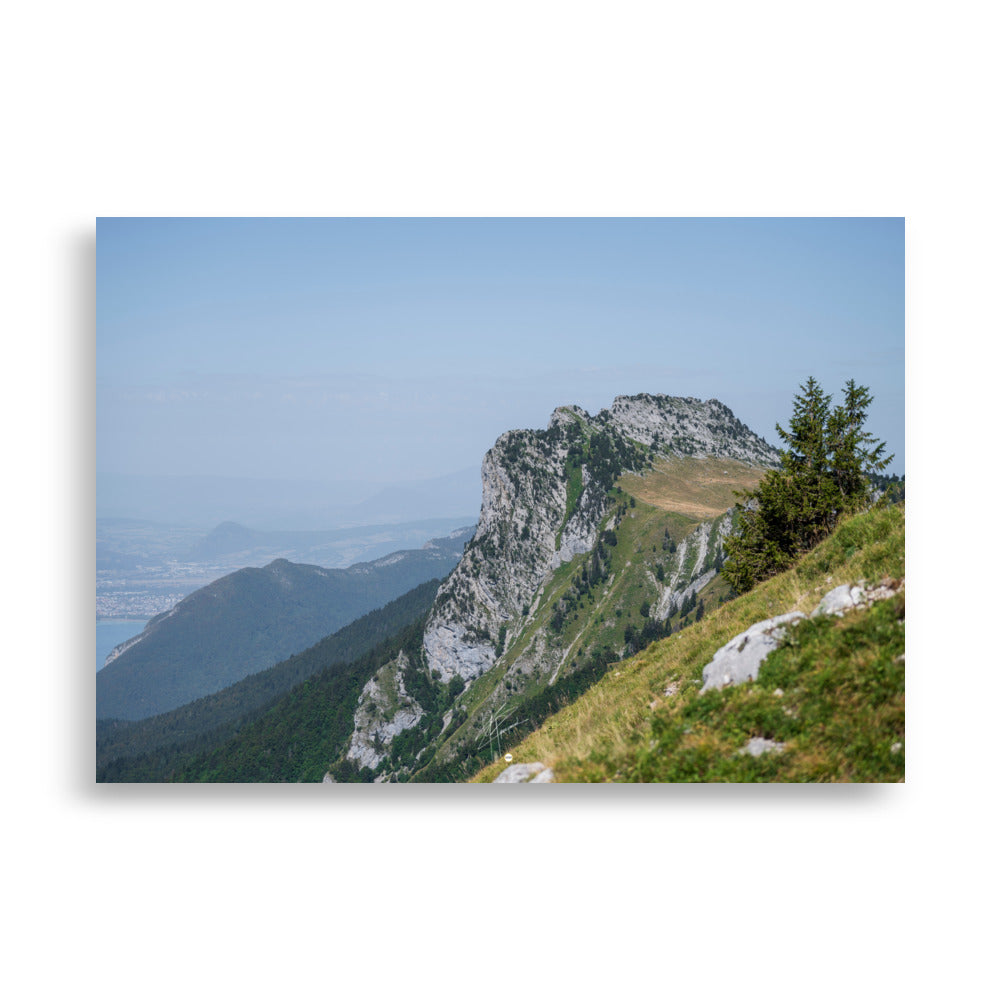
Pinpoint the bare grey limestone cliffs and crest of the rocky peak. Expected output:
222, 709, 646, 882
424, 395, 777, 680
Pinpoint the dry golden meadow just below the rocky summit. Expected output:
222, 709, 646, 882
618, 458, 764, 519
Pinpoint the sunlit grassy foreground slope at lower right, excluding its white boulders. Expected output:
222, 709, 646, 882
473, 506, 905, 781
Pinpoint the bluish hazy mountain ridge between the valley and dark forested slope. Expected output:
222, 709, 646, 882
97, 528, 473, 720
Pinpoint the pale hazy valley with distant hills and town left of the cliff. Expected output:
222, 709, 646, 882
96, 469, 481, 621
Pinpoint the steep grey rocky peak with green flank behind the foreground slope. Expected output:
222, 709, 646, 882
334, 395, 777, 780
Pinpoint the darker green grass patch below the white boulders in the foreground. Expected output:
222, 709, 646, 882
621, 595, 905, 782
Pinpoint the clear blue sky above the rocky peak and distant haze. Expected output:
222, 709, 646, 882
97, 219, 904, 504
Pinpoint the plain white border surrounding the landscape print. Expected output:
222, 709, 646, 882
0, 2, 997, 997
